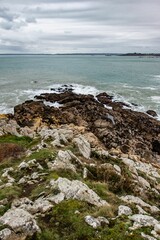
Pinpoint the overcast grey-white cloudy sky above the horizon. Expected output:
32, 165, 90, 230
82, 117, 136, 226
0, 0, 160, 53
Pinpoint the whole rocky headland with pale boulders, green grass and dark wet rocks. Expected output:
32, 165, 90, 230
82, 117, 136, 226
0, 86, 160, 240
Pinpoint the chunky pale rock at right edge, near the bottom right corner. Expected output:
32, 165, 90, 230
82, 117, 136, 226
129, 214, 158, 230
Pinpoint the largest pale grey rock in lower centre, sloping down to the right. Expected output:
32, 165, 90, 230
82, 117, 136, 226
50, 177, 109, 207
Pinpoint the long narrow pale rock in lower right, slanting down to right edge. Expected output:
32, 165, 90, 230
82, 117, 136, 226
120, 195, 160, 213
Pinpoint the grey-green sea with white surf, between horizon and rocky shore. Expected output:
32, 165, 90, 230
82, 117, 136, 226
0, 55, 160, 120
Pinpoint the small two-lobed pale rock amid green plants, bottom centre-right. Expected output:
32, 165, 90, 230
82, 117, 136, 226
85, 215, 109, 229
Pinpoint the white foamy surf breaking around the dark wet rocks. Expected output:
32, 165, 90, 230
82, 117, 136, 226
0, 83, 160, 120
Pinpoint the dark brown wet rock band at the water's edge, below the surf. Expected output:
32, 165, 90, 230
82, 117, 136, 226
11, 91, 160, 161
